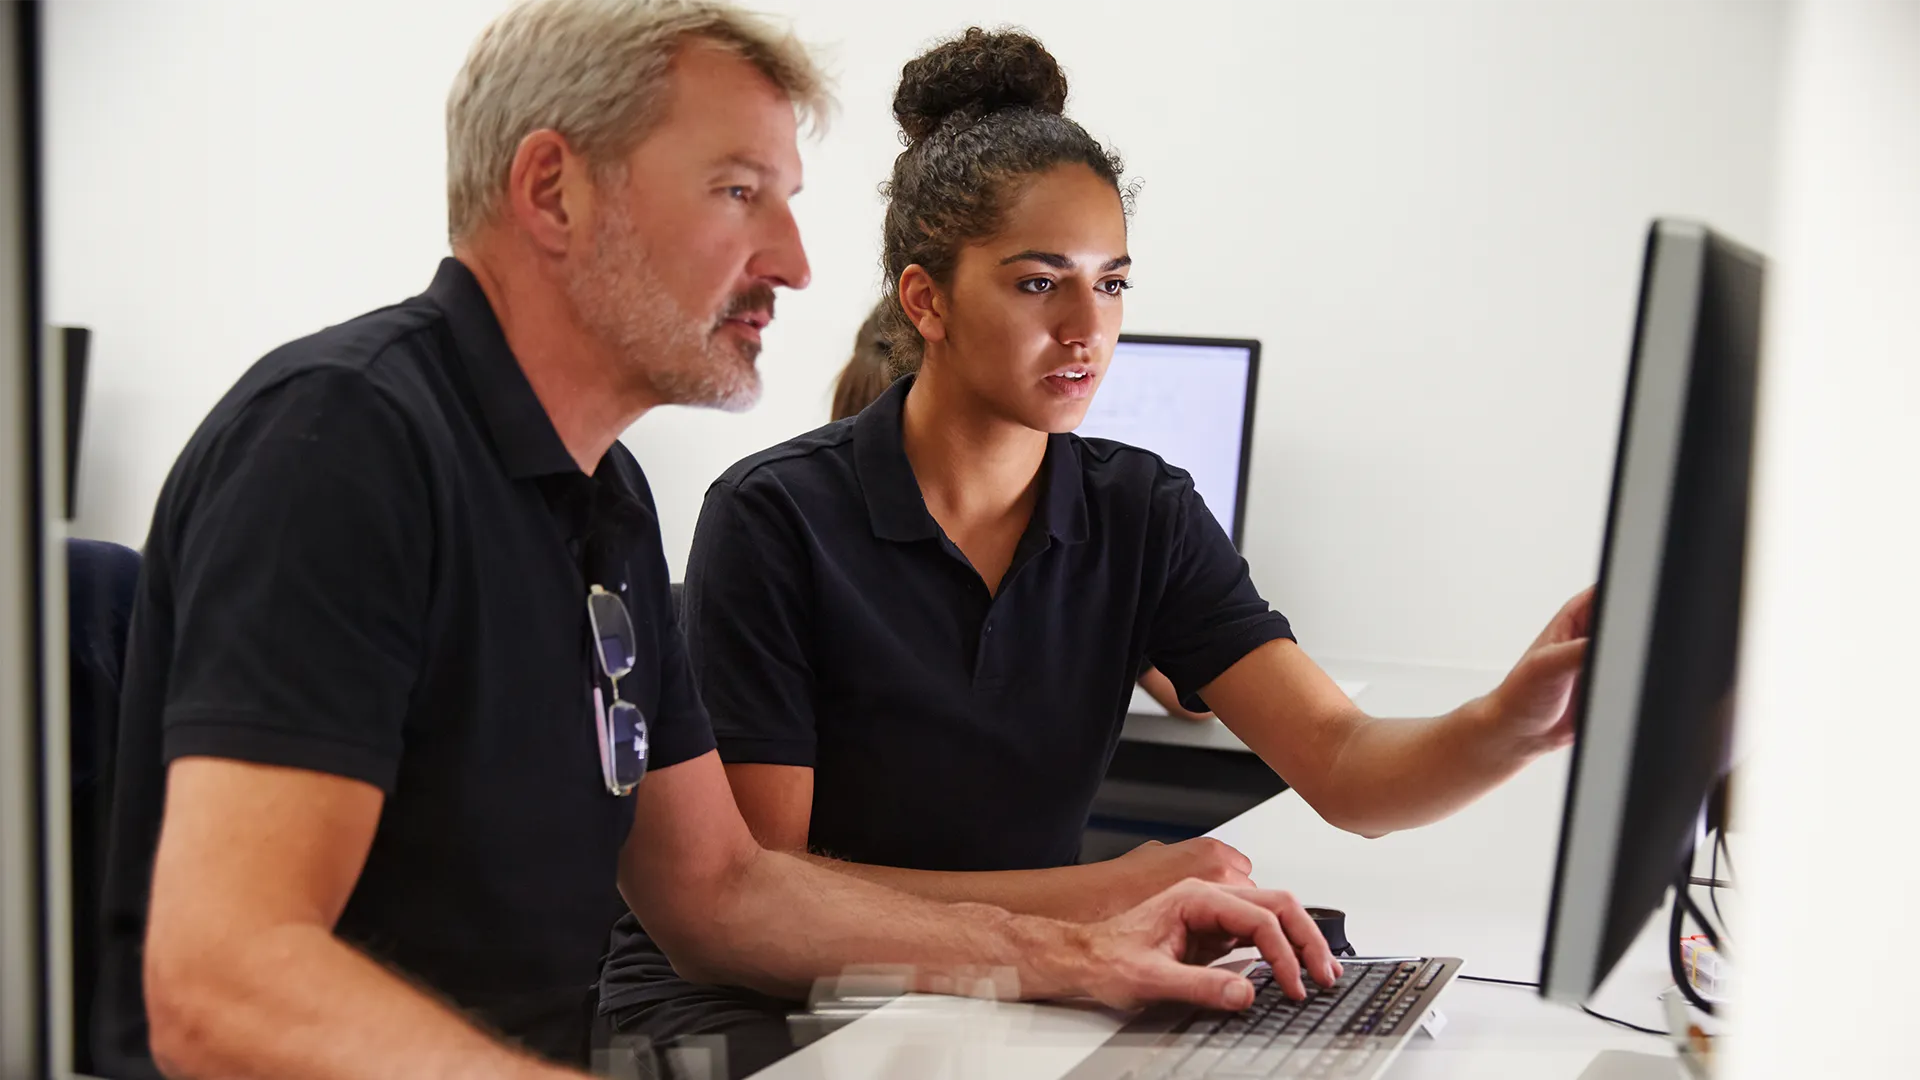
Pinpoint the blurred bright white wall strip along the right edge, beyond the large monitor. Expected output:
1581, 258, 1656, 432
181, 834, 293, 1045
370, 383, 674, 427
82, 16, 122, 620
1726, 0, 1920, 1060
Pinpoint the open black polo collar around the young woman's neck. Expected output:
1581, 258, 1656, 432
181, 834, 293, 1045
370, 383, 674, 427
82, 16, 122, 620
852, 375, 1087, 544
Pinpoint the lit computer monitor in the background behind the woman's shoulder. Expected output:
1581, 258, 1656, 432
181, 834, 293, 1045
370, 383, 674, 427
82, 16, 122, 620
1079, 334, 1260, 546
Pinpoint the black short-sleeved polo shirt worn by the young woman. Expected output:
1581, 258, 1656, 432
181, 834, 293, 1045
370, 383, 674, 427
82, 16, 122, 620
603, 368, 1292, 1007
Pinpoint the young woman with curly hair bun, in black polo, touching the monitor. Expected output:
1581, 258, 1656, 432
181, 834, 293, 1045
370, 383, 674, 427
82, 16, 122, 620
603, 29, 1586, 1068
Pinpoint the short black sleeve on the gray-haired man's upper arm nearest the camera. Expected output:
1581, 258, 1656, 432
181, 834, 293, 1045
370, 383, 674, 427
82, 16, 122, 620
163, 369, 432, 792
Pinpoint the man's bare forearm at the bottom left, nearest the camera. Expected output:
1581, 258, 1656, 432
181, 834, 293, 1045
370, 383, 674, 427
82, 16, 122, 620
146, 924, 580, 1080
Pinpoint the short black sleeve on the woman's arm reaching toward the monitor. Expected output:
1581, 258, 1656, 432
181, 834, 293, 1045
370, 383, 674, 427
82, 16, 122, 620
1146, 473, 1294, 709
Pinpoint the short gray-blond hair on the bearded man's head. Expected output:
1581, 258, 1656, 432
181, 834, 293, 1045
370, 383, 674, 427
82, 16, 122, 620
447, 0, 828, 244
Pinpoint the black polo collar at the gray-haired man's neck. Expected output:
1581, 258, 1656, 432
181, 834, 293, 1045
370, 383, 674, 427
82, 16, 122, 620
426, 258, 580, 480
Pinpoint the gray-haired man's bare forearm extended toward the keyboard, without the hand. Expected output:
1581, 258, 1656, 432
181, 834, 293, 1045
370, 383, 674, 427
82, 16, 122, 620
639, 849, 1087, 999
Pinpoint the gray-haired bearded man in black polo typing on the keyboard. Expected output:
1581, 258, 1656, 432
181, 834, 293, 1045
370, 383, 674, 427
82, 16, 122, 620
96, 0, 1334, 1080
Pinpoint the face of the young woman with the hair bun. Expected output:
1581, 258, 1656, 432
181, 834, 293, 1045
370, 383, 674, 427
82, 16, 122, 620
929, 165, 1133, 432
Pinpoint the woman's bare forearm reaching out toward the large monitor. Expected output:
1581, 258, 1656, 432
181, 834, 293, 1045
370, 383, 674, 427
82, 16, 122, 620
1302, 700, 1538, 836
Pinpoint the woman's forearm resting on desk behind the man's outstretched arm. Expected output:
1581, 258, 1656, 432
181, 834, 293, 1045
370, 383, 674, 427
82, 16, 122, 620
803, 853, 1158, 922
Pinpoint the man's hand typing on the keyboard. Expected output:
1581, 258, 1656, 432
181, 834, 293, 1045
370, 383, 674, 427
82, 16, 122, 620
1075, 880, 1340, 1009
